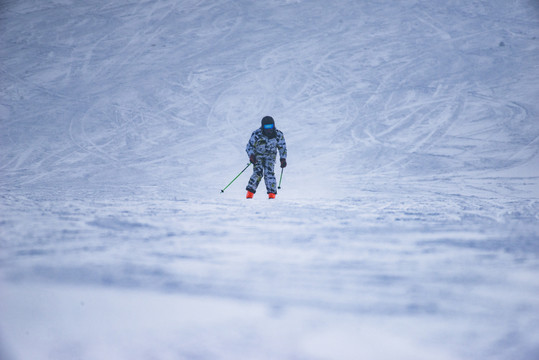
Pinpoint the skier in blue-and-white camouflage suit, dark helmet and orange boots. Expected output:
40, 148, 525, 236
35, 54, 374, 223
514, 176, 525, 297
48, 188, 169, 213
245, 116, 287, 199
